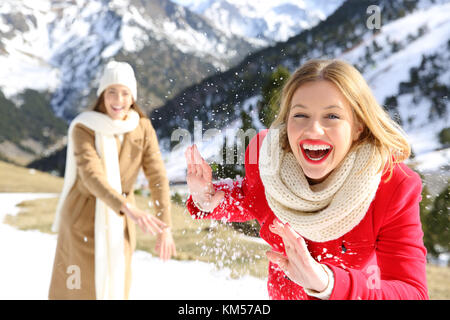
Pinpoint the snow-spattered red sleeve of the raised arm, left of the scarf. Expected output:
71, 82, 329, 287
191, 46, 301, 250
186, 130, 267, 222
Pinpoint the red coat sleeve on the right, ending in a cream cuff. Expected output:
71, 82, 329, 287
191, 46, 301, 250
326, 172, 429, 300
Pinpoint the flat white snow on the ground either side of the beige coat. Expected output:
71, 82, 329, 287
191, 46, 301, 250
0, 193, 268, 300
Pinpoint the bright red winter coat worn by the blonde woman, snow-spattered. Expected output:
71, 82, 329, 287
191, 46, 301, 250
186, 130, 428, 300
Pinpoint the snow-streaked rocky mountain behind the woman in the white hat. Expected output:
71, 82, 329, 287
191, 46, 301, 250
0, 0, 255, 119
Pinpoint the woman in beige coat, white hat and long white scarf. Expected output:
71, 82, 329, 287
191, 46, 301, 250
49, 61, 176, 299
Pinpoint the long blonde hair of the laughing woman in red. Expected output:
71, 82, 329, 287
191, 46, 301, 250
271, 59, 411, 181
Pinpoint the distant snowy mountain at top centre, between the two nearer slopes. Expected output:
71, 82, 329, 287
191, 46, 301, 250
174, 0, 344, 45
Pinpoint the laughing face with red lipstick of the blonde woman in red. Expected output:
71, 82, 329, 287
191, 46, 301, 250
287, 80, 363, 184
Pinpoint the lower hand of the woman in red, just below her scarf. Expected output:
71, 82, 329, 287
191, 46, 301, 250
266, 219, 328, 292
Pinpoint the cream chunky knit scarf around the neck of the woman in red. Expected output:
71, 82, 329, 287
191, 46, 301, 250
259, 127, 381, 242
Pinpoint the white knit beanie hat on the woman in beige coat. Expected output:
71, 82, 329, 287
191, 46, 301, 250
97, 61, 137, 101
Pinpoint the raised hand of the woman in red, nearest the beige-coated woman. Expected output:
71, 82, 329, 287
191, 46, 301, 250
184, 144, 225, 211
